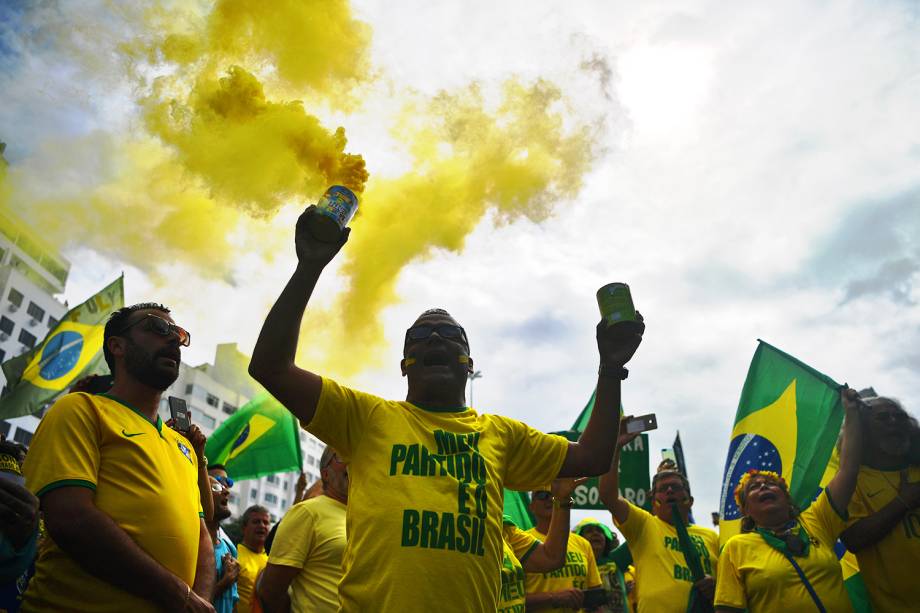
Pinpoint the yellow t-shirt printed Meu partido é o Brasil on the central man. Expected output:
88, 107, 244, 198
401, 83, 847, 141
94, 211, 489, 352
305, 379, 568, 613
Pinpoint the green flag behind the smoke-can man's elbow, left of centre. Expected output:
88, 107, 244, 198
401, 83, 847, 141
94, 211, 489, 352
205, 393, 303, 481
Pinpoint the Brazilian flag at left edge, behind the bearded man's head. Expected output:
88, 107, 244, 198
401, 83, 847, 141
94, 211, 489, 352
0, 277, 125, 419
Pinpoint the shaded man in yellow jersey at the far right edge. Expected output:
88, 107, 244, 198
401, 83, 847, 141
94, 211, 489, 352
841, 394, 920, 613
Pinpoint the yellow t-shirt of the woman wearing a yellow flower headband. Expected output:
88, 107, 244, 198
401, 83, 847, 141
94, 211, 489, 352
712, 490, 853, 613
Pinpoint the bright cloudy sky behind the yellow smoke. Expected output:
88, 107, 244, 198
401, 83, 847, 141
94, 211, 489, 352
0, 1, 920, 516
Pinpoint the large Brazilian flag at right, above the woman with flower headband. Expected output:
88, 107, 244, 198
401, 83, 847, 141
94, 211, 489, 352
719, 341, 843, 545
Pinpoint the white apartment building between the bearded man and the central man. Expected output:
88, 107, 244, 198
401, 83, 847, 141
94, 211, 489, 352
160, 343, 325, 522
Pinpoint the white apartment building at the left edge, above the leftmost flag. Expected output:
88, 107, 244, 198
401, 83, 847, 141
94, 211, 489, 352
0, 207, 70, 445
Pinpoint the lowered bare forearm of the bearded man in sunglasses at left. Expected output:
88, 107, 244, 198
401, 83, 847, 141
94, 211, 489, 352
41, 487, 214, 611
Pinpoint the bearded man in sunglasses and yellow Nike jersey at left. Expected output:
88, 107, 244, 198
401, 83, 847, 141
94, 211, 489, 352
22, 303, 214, 613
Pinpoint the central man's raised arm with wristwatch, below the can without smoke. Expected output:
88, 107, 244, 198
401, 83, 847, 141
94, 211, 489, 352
559, 313, 645, 477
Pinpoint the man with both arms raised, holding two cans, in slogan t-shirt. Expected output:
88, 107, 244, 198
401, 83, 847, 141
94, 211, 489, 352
249, 208, 645, 613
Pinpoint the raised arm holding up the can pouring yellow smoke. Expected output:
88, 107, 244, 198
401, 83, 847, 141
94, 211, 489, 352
249, 206, 349, 423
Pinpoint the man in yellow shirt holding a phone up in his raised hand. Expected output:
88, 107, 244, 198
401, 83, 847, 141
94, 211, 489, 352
599, 424, 719, 613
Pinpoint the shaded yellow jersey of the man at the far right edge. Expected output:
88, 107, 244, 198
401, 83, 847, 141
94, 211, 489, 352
847, 466, 920, 613
